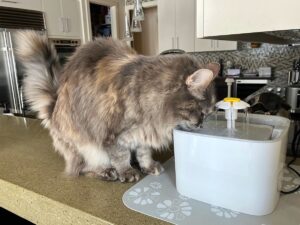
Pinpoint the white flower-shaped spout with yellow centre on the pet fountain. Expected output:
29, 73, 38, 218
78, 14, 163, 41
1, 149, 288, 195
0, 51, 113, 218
216, 97, 250, 129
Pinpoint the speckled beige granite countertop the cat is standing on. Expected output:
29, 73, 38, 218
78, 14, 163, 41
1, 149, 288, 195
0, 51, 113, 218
0, 116, 171, 225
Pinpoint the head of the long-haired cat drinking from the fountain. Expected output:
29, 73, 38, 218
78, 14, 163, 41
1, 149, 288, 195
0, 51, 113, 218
171, 63, 220, 126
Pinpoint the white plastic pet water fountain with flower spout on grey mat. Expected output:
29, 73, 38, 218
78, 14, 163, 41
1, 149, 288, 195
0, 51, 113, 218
174, 89, 290, 215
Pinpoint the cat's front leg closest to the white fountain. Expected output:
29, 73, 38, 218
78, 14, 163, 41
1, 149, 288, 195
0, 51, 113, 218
136, 147, 164, 175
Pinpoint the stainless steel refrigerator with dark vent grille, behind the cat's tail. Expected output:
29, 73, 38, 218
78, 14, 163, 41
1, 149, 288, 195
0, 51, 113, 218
0, 7, 46, 116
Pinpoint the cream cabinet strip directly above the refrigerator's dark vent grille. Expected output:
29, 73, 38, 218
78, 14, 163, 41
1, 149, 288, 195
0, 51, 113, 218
0, 0, 42, 11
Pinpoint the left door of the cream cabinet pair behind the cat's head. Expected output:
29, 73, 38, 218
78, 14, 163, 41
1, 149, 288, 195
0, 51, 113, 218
157, 0, 176, 53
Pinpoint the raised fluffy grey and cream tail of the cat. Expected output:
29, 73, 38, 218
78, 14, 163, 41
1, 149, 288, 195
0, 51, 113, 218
16, 31, 60, 127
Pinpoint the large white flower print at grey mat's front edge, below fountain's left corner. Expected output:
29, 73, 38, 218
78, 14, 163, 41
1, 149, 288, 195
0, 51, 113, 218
156, 199, 192, 221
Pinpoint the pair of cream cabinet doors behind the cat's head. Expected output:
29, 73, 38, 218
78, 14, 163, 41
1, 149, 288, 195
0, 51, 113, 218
157, 0, 195, 52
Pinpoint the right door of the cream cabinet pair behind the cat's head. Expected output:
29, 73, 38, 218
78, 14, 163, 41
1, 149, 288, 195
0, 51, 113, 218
175, 0, 195, 52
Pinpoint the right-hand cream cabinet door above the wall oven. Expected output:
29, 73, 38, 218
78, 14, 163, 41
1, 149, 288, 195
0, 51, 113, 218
61, 0, 81, 38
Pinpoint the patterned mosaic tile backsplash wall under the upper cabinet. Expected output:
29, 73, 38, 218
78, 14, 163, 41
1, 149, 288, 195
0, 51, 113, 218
192, 43, 300, 93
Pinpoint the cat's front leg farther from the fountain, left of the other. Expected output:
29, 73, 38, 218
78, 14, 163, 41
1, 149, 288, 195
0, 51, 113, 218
108, 145, 140, 182
